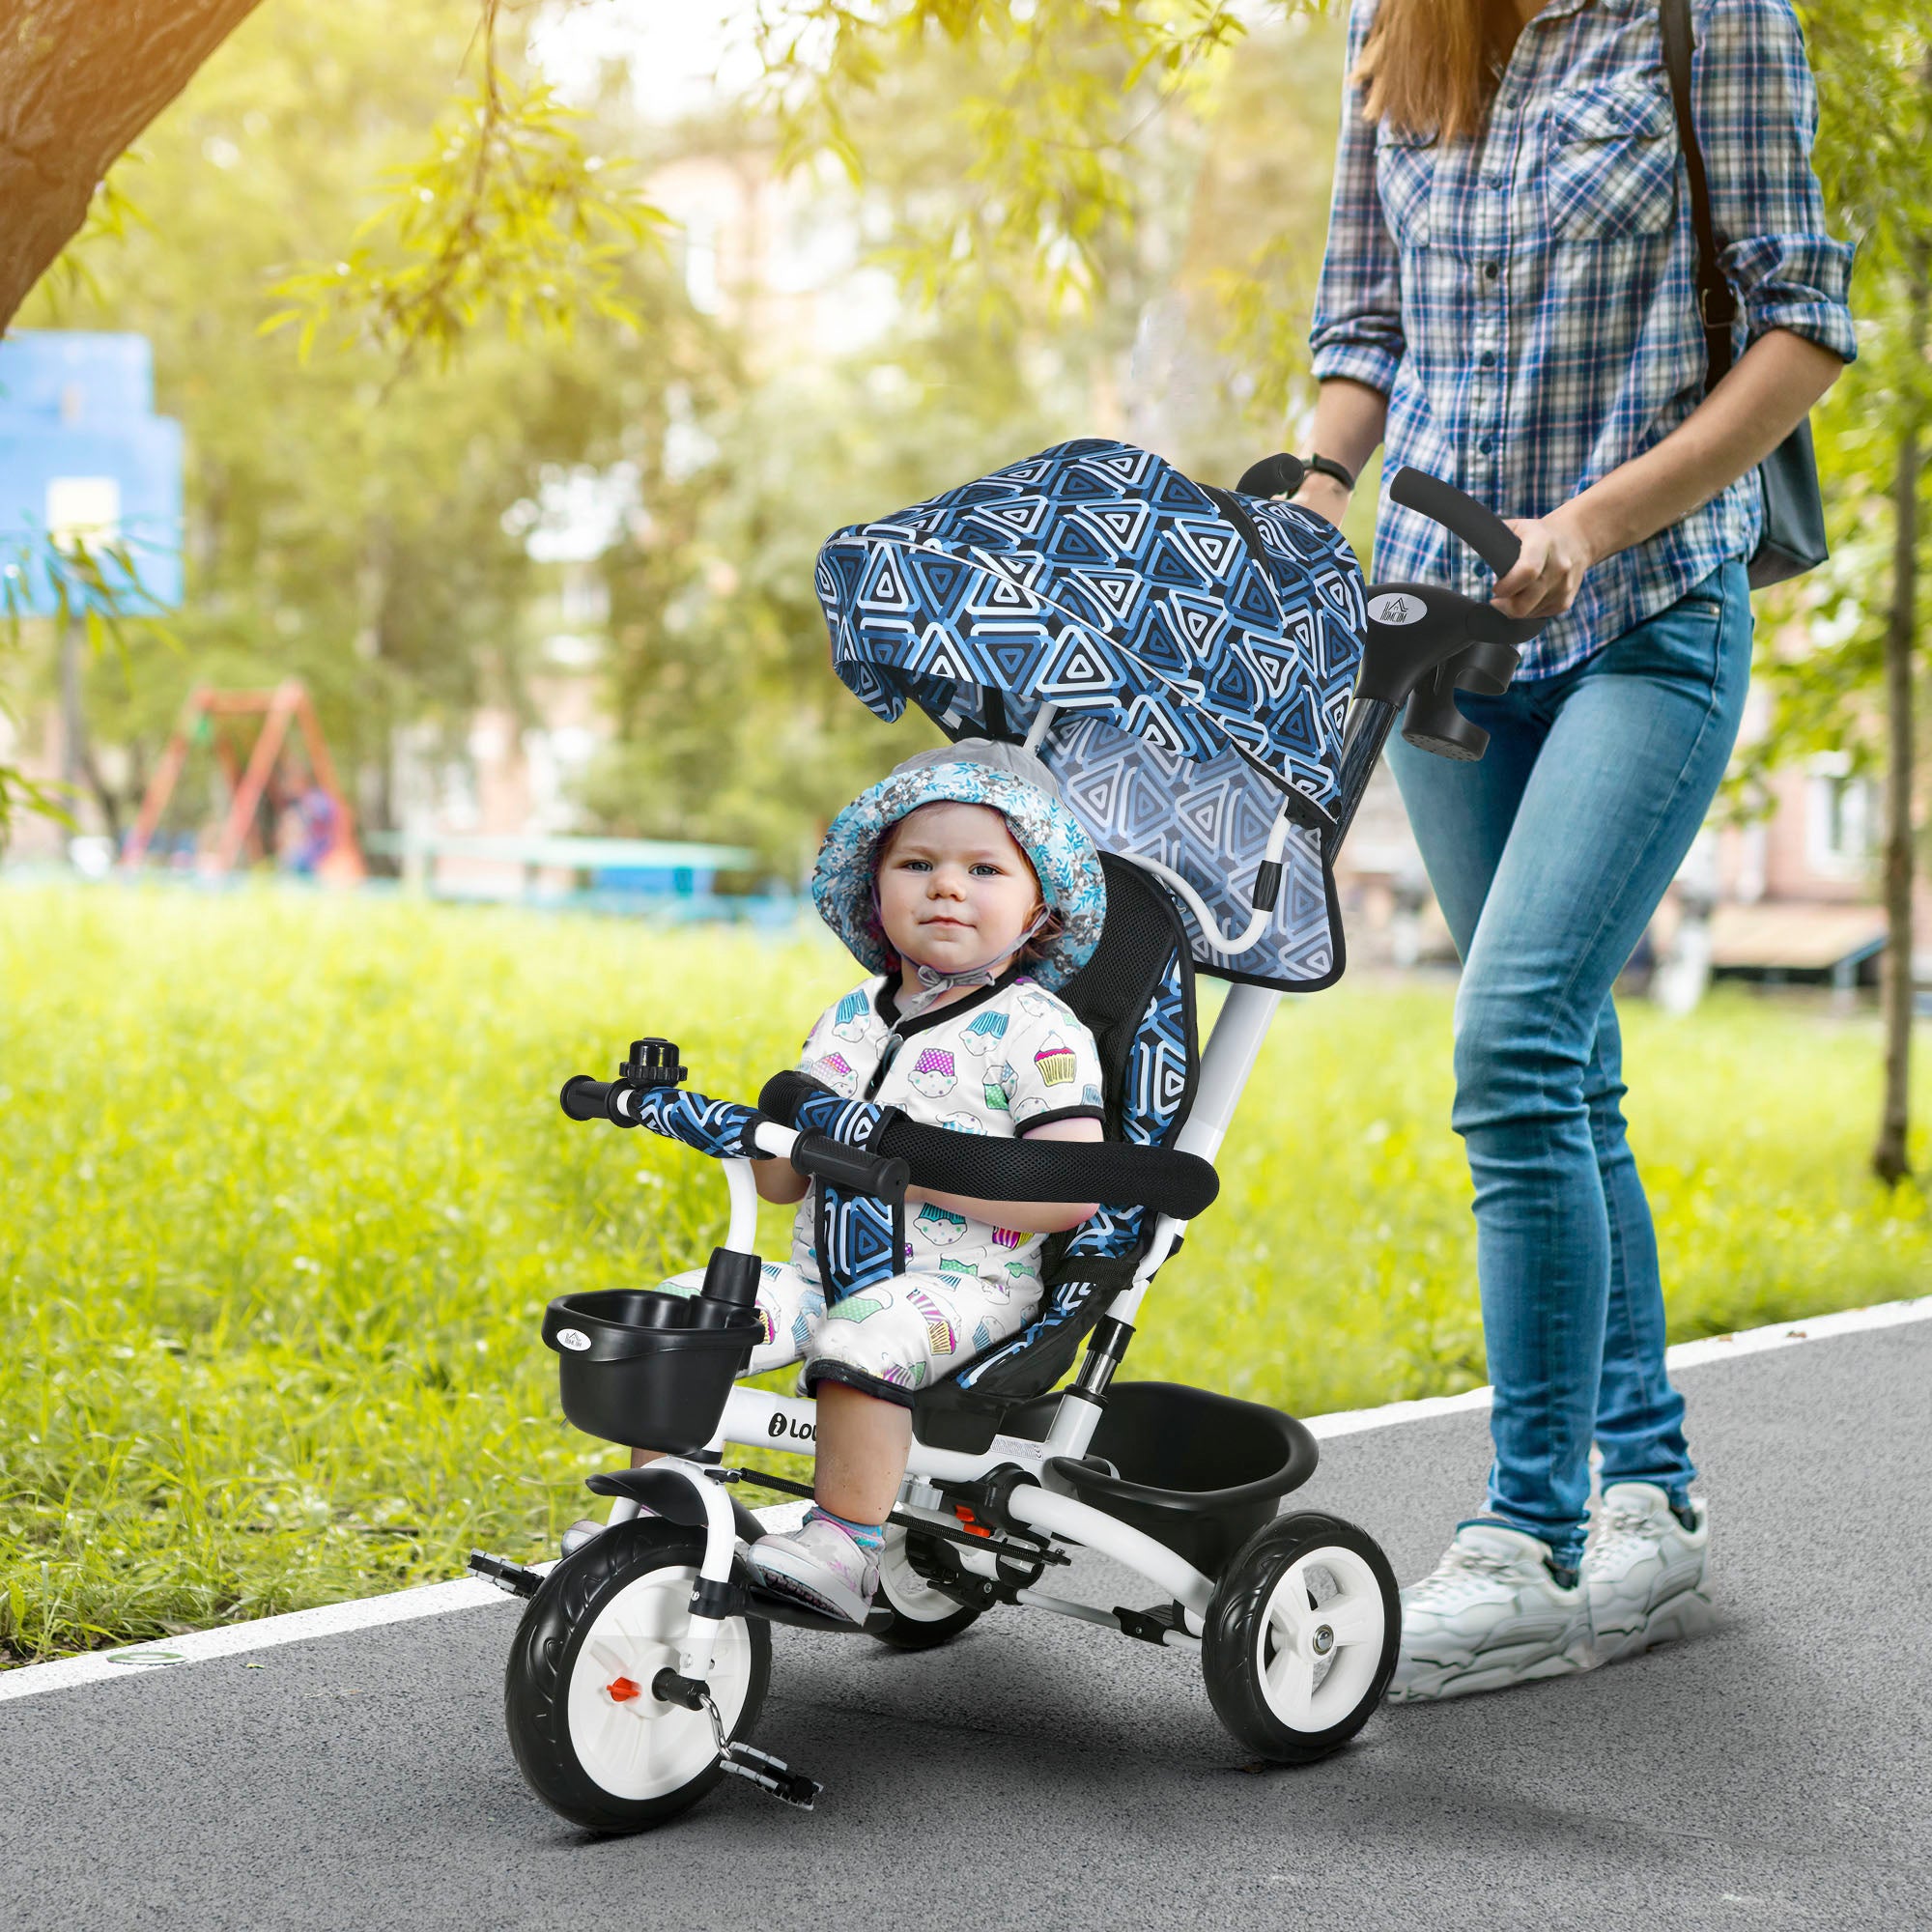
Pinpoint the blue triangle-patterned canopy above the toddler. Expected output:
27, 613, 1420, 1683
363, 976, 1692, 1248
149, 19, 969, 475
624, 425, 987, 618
817, 437, 1366, 991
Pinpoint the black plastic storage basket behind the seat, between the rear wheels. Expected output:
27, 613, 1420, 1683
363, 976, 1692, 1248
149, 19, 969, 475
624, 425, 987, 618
1043, 1381, 1320, 1577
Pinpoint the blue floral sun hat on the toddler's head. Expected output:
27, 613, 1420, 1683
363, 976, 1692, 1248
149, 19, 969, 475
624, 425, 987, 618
811, 738, 1107, 989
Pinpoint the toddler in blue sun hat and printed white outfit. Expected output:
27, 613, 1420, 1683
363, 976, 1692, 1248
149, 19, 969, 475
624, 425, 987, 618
667, 740, 1107, 1623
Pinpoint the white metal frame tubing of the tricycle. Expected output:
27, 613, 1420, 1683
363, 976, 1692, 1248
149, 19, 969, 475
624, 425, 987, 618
595, 985, 1281, 1679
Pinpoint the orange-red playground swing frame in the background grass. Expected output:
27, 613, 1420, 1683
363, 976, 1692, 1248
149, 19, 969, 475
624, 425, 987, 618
120, 678, 367, 885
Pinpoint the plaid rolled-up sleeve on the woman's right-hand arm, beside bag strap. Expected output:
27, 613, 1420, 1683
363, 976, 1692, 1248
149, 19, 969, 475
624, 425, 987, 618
1690, 0, 1859, 361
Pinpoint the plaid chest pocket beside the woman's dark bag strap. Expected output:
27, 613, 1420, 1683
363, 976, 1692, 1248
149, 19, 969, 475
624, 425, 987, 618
1544, 87, 1677, 242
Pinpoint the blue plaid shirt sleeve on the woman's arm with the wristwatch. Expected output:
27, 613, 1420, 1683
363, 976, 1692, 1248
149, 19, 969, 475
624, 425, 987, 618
1308, 0, 1405, 396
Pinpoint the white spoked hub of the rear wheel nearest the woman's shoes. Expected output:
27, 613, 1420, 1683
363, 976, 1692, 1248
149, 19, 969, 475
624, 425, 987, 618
1254, 1544, 1387, 1733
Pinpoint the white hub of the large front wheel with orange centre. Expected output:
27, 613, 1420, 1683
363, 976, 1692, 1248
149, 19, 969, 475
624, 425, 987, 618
564, 1565, 752, 1799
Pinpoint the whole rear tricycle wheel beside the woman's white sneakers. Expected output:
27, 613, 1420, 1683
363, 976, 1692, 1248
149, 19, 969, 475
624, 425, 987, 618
1202, 1513, 1403, 1764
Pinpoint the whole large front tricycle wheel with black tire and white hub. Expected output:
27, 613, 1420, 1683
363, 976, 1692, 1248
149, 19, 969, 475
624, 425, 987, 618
504, 1517, 771, 1832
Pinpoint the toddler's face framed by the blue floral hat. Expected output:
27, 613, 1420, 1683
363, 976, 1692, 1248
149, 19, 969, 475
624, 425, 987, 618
879, 804, 1039, 972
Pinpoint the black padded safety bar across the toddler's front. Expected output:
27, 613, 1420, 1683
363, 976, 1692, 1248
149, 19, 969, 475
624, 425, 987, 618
757, 1068, 1221, 1221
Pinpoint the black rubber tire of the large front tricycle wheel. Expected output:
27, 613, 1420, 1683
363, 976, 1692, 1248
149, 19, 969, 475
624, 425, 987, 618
502, 1517, 771, 1832
